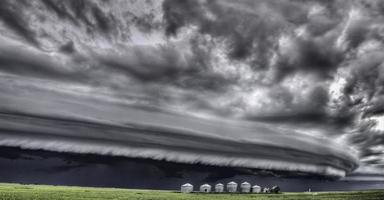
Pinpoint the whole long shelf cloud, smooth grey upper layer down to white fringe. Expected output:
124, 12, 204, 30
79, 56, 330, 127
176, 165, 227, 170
0, 74, 357, 177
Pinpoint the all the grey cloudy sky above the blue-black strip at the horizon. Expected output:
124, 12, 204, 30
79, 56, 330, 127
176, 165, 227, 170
0, 0, 384, 191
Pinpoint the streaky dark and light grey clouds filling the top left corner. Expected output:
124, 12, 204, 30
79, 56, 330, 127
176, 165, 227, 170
0, 0, 161, 49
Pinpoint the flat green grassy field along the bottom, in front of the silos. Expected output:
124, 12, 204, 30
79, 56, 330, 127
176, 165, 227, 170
0, 184, 384, 200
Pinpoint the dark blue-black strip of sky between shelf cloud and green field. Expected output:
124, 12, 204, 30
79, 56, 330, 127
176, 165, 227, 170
0, 147, 384, 192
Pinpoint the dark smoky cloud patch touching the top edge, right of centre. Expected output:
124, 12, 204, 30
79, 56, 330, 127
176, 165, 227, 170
163, 0, 282, 63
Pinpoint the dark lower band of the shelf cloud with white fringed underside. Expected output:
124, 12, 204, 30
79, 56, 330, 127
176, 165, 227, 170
0, 113, 356, 177
